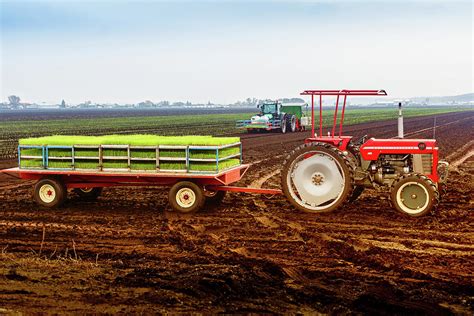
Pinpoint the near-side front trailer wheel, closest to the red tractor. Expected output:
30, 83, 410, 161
168, 181, 205, 213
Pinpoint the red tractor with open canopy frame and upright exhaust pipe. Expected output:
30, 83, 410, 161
281, 90, 448, 216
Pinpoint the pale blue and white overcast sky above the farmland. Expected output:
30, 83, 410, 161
0, 0, 474, 103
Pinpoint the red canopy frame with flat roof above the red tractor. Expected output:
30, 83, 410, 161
301, 90, 387, 138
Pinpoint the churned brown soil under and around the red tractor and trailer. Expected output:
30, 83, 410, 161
0, 111, 474, 314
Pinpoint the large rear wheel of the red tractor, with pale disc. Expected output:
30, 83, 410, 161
281, 143, 354, 213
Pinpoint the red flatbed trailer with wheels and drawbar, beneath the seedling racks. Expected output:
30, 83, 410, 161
0, 164, 281, 213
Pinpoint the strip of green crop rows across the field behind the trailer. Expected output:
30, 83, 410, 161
4, 107, 467, 140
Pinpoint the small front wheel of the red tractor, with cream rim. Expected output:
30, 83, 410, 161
390, 174, 439, 217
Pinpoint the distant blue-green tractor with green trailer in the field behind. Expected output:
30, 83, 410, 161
236, 101, 311, 133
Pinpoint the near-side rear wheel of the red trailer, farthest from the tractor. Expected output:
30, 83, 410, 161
33, 179, 67, 208
